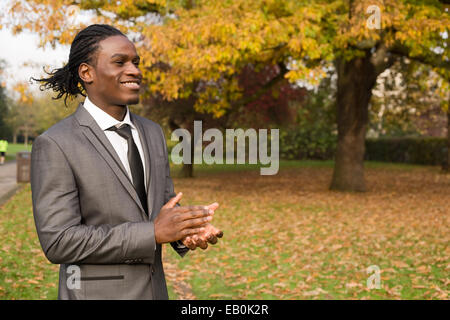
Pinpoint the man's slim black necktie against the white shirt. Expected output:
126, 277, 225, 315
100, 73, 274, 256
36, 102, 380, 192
110, 124, 148, 214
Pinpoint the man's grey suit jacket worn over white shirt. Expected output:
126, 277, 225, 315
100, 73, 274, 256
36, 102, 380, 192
31, 104, 189, 299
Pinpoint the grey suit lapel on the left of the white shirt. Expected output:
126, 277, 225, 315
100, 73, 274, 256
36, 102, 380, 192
75, 103, 148, 220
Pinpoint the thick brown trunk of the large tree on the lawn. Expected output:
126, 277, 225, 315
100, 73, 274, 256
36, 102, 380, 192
330, 52, 377, 192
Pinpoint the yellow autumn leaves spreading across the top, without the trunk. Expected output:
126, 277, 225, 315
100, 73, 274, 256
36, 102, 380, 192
0, 0, 450, 117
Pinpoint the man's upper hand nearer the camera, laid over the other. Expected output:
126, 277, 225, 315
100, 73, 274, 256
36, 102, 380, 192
154, 192, 213, 244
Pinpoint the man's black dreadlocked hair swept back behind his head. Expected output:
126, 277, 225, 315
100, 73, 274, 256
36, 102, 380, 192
31, 24, 125, 107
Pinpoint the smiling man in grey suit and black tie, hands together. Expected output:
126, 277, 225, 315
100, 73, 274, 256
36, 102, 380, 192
31, 25, 222, 299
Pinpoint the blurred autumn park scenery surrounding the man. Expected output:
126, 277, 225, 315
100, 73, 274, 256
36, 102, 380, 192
0, 0, 450, 299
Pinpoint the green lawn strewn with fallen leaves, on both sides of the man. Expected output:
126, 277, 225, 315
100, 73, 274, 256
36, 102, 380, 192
0, 161, 450, 299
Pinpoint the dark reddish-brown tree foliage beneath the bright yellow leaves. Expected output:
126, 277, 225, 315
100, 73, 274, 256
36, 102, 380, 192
142, 65, 306, 177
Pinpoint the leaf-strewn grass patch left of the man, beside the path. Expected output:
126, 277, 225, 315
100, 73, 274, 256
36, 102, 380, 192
0, 184, 58, 300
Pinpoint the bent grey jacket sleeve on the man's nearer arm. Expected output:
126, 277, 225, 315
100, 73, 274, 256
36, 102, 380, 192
31, 135, 155, 264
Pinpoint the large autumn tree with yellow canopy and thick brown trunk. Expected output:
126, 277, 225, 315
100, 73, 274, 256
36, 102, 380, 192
6, 0, 450, 191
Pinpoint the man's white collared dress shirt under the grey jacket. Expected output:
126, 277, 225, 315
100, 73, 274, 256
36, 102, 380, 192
83, 97, 147, 191
